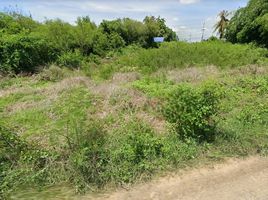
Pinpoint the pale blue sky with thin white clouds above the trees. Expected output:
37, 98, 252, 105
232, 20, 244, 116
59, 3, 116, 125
0, 0, 247, 41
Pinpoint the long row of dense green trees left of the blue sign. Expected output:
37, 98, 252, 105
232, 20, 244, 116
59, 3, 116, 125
0, 13, 176, 73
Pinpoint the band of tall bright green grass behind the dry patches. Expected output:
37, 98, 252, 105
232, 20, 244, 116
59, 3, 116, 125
111, 41, 268, 73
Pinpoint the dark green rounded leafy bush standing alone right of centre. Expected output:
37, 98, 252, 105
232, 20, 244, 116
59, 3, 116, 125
163, 84, 220, 141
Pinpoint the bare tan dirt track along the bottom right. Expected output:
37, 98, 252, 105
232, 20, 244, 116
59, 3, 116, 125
94, 157, 268, 200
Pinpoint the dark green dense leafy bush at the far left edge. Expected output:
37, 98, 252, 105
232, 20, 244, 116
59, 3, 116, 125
0, 34, 57, 73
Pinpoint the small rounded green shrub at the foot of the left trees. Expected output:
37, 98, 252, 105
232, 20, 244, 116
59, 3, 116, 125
57, 50, 83, 68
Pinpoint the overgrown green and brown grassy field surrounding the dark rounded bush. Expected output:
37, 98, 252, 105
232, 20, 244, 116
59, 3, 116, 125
0, 42, 268, 198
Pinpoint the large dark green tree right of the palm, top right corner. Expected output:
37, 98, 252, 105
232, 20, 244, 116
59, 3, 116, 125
226, 0, 268, 47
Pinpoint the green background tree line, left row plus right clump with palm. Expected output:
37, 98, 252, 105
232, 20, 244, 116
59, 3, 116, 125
0, 0, 268, 74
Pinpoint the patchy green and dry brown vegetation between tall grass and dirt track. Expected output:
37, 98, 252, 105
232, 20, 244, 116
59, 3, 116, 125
0, 63, 268, 198
